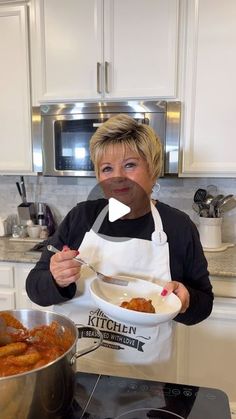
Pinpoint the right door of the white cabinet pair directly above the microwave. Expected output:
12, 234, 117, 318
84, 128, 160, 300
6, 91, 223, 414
104, 0, 178, 98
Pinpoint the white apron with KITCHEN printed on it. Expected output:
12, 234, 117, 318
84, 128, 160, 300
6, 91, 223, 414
54, 203, 176, 381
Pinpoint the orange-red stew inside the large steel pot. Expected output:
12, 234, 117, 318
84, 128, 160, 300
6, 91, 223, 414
0, 312, 74, 377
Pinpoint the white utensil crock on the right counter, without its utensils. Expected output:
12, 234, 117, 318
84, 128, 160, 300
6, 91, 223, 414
199, 217, 222, 249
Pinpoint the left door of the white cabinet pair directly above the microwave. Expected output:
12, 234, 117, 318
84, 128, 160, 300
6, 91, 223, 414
31, 0, 102, 101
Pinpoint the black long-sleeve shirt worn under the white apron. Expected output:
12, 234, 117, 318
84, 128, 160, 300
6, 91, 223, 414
26, 199, 213, 325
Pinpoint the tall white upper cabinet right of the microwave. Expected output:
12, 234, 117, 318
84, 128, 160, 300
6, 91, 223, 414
179, 0, 236, 177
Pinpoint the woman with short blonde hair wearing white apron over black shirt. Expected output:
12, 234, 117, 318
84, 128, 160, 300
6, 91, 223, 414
26, 115, 213, 381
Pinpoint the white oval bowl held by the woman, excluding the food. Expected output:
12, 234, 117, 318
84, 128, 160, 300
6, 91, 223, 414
90, 276, 181, 327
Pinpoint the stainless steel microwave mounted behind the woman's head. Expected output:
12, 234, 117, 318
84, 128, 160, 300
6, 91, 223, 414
33, 101, 181, 177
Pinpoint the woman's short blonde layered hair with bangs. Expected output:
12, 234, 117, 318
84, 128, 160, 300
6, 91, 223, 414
90, 114, 162, 180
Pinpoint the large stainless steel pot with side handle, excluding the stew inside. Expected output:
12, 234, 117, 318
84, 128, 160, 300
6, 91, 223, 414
0, 310, 102, 419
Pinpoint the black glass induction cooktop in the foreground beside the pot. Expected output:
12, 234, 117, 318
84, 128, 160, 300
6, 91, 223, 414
67, 372, 231, 419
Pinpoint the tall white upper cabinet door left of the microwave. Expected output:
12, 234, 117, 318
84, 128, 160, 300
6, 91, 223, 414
0, 4, 32, 174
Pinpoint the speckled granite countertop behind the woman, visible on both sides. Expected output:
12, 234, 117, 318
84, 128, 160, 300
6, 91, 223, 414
0, 237, 236, 278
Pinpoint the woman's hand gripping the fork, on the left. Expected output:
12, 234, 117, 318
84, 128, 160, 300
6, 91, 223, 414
50, 246, 81, 288
